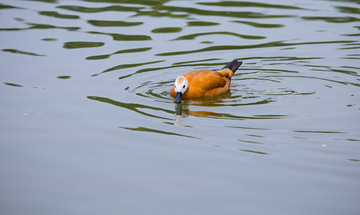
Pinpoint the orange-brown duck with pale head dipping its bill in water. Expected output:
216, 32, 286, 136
170, 59, 243, 103
